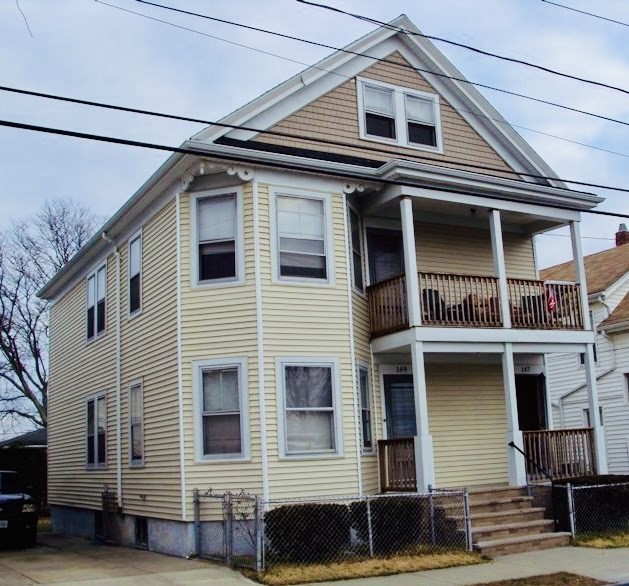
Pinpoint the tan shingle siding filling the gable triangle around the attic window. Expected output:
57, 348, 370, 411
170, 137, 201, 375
255, 53, 517, 178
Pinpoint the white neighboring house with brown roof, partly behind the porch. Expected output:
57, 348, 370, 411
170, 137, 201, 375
540, 224, 629, 474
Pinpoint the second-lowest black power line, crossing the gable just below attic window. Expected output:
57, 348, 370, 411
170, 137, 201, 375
0, 86, 626, 189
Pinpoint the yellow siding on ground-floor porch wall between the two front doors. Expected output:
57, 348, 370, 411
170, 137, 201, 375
426, 364, 509, 487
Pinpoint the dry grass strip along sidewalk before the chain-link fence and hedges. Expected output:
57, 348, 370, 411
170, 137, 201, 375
247, 551, 480, 586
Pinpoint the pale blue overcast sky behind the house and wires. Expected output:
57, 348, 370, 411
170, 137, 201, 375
0, 0, 629, 266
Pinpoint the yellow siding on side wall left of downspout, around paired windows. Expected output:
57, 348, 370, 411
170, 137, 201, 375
48, 255, 116, 509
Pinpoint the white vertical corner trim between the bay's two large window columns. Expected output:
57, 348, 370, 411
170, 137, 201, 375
251, 179, 270, 501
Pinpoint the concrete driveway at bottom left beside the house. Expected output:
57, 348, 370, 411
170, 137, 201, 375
0, 534, 252, 586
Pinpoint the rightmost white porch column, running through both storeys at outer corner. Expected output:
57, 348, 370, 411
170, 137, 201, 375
570, 220, 607, 474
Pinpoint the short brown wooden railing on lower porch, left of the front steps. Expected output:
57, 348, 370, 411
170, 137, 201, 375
378, 437, 417, 492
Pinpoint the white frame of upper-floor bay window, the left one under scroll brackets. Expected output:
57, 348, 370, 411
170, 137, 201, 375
190, 186, 245, 288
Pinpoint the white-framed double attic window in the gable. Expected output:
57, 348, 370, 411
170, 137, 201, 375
358, 79, 442, 152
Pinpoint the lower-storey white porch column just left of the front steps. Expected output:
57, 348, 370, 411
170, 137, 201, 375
411, 342, 435, 492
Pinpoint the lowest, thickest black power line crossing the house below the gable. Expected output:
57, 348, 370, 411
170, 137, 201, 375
0, 120, 629, 218
